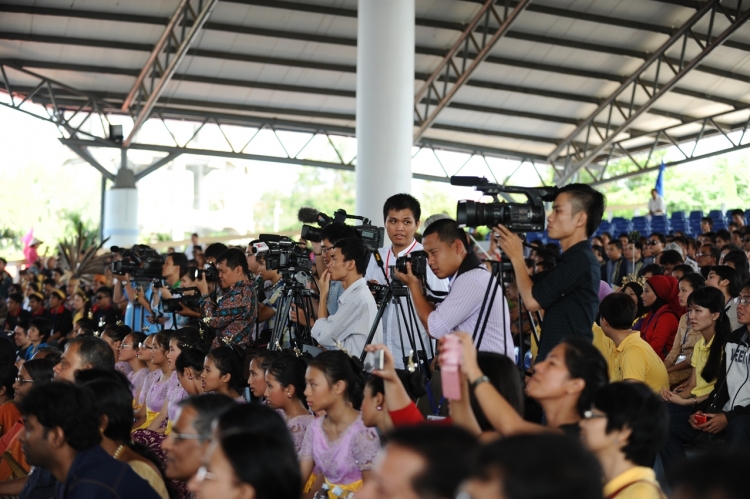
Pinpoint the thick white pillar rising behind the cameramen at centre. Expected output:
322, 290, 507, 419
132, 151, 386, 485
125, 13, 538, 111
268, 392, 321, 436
356, 0, 415, 225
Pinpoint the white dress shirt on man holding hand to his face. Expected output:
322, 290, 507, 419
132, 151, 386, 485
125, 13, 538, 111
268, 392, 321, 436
311, 278, 383, 358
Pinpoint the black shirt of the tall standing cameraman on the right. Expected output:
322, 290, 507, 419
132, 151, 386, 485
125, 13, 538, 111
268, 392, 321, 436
531, 241, 601, 360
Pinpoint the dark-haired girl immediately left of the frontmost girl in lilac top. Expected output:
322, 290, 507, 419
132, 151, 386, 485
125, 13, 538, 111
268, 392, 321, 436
265, 352, 315, 454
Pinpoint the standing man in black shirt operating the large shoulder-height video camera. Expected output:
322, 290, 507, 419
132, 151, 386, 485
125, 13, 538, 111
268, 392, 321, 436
494, 184, 606, 360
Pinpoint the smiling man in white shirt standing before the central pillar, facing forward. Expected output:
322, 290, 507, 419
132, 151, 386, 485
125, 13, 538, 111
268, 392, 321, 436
365, 194, 449, 369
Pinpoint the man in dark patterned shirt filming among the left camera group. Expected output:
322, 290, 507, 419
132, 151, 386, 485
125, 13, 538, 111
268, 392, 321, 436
195, 248, 258, 348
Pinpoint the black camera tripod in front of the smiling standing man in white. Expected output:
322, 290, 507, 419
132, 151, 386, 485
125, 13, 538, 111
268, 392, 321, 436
360, 252, 435, 378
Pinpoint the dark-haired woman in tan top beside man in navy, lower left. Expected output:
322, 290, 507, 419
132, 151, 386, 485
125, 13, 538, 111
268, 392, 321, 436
76, 369, 170, 499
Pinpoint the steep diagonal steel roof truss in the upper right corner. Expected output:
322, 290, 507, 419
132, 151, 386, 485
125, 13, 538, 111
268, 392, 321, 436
548, 0, 750, 185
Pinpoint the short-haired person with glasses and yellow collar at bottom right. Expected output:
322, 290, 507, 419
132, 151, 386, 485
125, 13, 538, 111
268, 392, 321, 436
581, 381, 669, 499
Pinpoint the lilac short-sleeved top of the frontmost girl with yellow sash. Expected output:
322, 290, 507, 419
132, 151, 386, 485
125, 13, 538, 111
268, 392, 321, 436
299, 416, 380, 485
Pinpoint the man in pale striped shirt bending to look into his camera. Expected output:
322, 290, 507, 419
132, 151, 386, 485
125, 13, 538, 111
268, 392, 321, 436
396, 219, 526, 359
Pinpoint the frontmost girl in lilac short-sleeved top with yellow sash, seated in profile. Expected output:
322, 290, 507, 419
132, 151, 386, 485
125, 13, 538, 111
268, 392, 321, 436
299, 350, 380, 499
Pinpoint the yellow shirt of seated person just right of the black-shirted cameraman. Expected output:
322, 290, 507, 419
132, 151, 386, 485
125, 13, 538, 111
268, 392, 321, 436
607, 332, 669, 393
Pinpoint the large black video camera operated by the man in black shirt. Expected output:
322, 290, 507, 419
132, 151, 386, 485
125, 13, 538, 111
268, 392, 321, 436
451, 176, 557, 232
